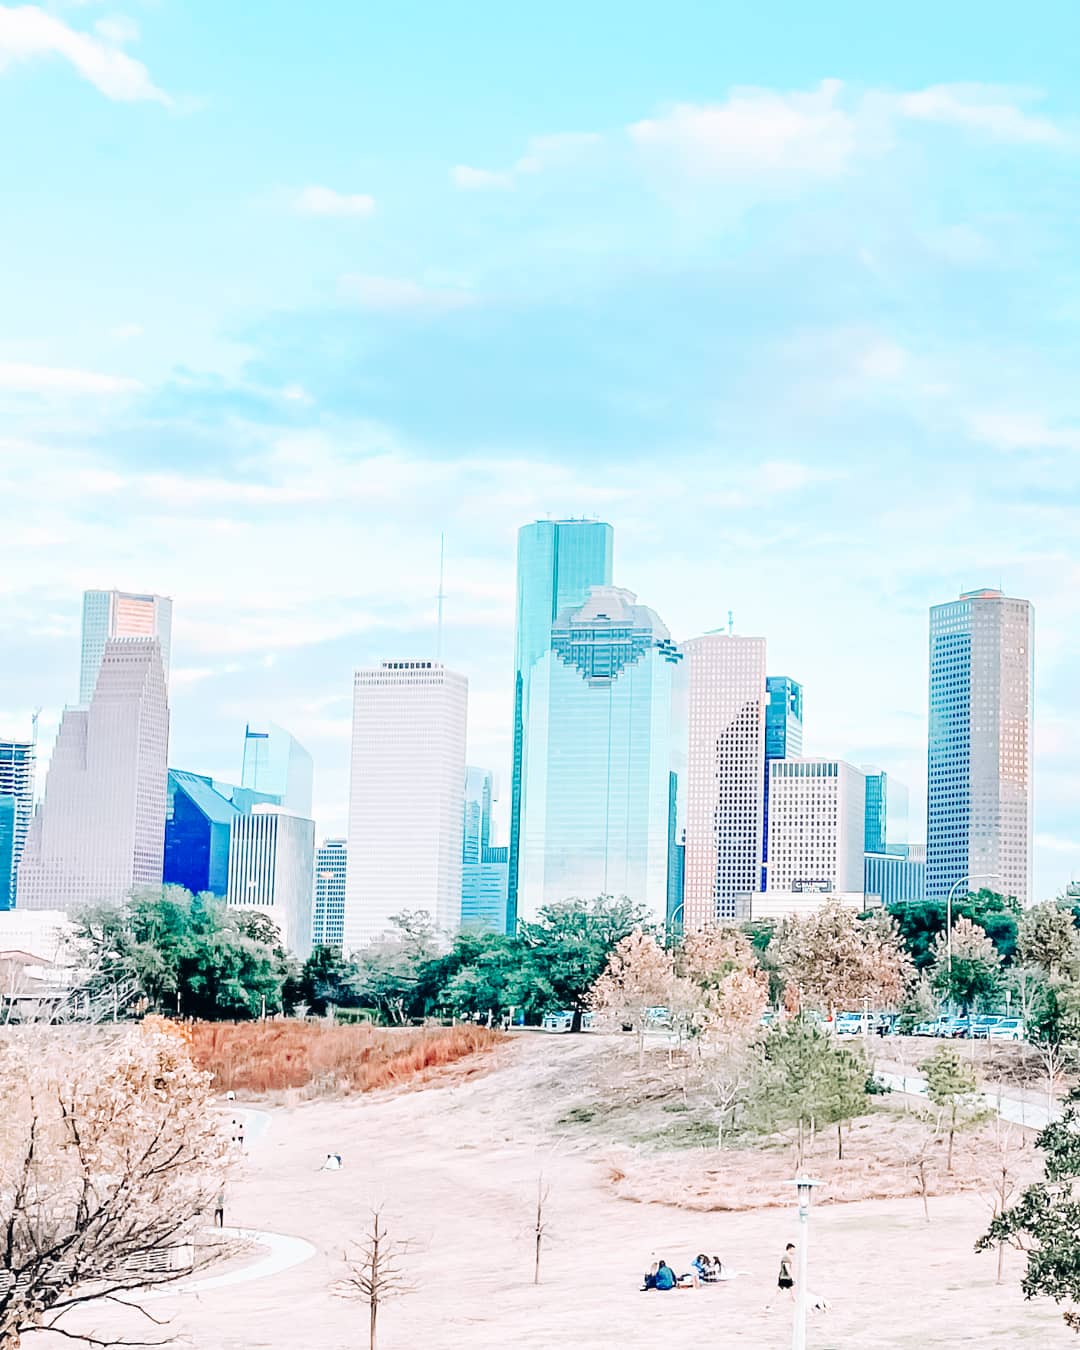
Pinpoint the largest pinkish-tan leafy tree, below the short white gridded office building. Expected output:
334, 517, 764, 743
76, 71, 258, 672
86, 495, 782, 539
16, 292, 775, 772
775, 900, 911, 1013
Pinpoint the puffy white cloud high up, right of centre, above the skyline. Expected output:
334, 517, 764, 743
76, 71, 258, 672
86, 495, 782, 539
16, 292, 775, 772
629, 80, 857, 180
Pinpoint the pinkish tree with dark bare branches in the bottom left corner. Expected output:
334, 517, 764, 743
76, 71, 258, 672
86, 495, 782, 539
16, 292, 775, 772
0, 1027, 227, 1350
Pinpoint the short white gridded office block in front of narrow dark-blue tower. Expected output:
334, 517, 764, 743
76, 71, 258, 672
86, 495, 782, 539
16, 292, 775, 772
768, 759, 867, 892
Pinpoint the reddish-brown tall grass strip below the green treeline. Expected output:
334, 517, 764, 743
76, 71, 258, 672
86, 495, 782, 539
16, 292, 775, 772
192, 1022, 505, 1094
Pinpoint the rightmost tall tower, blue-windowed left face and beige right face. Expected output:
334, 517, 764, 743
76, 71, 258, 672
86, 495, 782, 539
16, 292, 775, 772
926, 590, 1034, 905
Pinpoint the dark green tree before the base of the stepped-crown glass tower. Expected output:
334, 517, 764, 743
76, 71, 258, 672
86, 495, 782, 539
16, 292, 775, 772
517, 895, 649, 1031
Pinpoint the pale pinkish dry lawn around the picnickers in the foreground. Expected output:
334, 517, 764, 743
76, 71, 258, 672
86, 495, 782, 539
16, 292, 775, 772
35, 1037, 1076, 1350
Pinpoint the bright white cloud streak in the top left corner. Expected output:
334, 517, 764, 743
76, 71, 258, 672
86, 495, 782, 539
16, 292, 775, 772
0, 5, 171, 107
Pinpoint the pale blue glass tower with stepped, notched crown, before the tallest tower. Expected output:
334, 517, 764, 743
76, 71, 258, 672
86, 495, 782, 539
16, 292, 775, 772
517, 586, 682, 921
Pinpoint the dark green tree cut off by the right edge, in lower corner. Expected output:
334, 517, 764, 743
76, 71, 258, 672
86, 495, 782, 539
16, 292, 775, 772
976, 1088, 1080, 1331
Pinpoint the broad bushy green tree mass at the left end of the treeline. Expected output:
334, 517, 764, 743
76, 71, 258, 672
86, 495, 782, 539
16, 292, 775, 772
76, 886, 289, 1021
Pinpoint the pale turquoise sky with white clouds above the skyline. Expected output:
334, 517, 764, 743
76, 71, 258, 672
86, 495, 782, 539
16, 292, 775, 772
0, 0, 1080, 896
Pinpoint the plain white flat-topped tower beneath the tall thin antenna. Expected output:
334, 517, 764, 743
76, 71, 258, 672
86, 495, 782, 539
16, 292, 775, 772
343, 662, 468, 952
